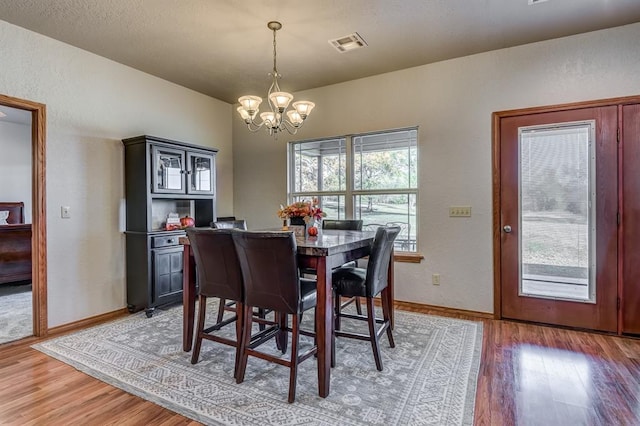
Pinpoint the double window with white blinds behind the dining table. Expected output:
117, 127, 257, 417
289, 128, 418, 251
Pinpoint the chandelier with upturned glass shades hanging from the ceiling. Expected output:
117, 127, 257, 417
238, 21, 316, 136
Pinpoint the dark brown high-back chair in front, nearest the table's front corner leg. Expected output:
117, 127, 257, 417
233, 231, 318, 403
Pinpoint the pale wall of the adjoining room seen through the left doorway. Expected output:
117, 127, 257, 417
0, 120, 32, 223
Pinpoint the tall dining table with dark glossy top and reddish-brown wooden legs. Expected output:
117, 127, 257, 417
180, 229, 394, 398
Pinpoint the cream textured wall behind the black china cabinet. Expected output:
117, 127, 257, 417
0, 21, 233, 327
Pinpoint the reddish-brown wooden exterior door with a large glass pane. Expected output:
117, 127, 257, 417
496, 105, 618, 332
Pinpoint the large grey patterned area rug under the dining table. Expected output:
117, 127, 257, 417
34, 299, 482, 425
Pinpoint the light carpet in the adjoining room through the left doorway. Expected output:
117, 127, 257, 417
0, 285, 33, 344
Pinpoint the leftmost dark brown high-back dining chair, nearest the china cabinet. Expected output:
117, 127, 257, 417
187, 228, 244, 377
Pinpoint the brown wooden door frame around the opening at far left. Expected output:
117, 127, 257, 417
0, 95, 48, 337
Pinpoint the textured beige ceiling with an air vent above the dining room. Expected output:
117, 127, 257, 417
0, 0, 640, 103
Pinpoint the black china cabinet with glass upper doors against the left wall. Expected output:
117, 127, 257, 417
122, 135, 217, 317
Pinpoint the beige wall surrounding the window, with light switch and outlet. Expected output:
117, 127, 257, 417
233, 23, 640, 312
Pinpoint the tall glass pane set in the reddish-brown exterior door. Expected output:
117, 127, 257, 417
519, 122, 595, 302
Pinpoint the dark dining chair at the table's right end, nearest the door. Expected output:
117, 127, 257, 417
332, 226, 400, 371
